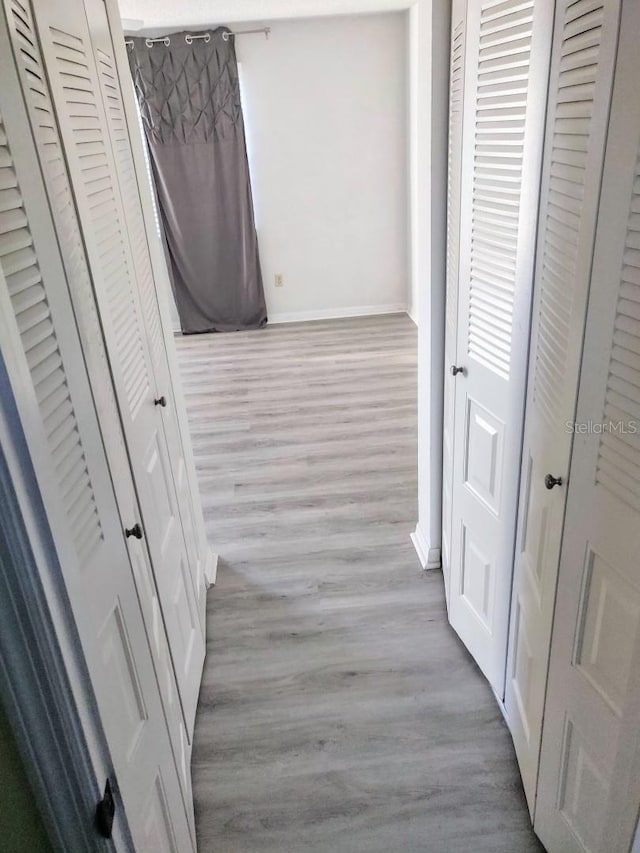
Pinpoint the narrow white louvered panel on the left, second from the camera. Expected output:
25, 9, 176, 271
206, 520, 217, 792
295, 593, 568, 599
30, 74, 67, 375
5, 0, 191, 812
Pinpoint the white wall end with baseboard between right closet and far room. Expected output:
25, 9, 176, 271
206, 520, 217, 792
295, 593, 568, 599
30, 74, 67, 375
407, 0, 452, 569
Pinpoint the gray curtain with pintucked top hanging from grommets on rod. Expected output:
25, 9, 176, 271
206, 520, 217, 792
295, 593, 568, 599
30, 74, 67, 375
128, 28, 267, 333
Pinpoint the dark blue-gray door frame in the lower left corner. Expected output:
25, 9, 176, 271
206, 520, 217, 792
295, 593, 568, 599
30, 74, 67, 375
0, 353, 131, 853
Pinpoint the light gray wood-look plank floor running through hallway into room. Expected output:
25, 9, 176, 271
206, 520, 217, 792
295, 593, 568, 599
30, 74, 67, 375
178, 315, 542, 853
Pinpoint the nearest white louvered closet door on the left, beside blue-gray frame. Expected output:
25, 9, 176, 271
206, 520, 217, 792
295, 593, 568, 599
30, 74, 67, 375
0, 16, 194, 853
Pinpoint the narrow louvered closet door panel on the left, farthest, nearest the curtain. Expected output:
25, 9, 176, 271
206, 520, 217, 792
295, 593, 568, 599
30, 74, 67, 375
84, 0, 206, 624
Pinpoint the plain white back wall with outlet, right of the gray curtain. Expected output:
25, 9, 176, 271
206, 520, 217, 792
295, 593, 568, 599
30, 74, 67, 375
236, 12, 408, 322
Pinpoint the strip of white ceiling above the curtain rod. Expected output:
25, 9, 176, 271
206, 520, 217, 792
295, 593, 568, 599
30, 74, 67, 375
119, 0, 415, 32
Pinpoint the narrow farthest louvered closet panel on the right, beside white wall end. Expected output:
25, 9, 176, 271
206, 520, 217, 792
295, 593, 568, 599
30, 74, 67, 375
442, 0, 466, 605
